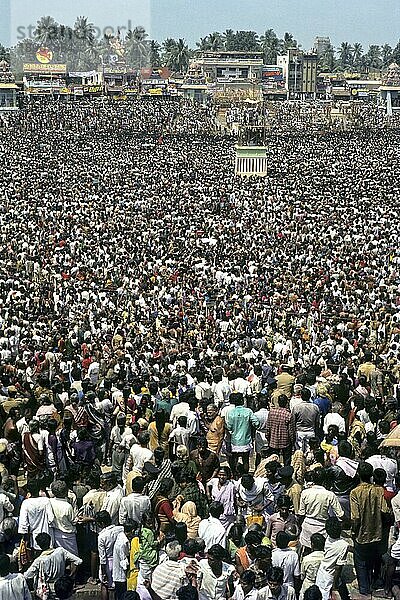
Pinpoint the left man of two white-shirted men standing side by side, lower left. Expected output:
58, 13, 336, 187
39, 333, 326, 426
18, 480, 54, 550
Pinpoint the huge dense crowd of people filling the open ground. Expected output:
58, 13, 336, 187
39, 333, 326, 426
0, 99, 400, 600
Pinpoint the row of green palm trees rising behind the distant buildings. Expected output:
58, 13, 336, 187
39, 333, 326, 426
0, 16, 400, 74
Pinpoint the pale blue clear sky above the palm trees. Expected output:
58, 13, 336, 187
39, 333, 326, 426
0, 0, 400, 49
